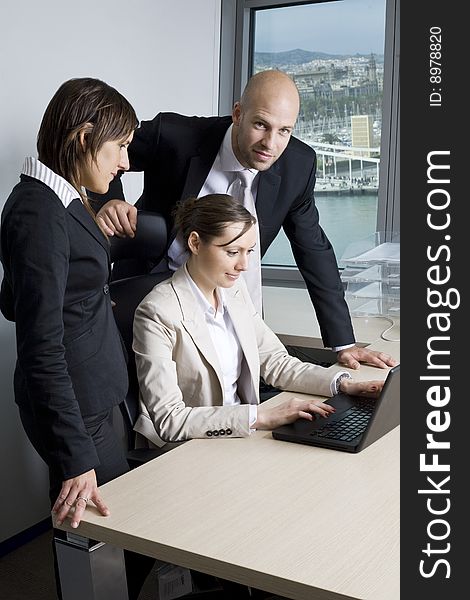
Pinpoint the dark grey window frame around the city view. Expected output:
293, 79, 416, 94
219, 0, 400, 287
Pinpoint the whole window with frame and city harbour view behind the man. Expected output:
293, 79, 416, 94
220, 0, 399, 279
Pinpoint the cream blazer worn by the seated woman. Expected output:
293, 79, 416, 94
133, 267, 344, 446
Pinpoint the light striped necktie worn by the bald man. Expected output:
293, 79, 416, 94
237, 169, 263, 315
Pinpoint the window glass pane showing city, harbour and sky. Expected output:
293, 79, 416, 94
252, 0, 386, 266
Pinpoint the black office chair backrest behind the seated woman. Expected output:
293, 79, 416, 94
109, 211, 171, 448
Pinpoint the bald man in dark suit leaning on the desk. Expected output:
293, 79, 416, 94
95, 70, 395, 369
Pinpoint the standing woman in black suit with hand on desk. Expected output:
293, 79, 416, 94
0, 78, 151, 596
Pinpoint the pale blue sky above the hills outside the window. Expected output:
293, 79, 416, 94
255, 0, 385, 54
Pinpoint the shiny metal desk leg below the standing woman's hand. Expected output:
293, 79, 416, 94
54, 533, 129, 600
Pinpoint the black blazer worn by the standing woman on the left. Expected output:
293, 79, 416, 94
0, 175, 128, 479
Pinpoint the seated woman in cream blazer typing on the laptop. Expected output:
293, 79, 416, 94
133, 194, 383, 446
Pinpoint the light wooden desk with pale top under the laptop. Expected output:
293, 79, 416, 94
55, 336, 400, 600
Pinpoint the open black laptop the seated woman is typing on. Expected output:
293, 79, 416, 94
272, 365, 400, 452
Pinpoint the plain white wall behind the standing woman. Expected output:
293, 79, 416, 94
0, 0, 220, 542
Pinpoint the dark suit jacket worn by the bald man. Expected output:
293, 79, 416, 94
94, 113, 354, 346
